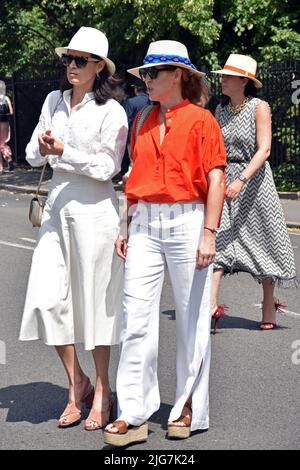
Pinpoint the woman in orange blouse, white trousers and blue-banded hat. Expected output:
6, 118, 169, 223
104, 41, 226, 446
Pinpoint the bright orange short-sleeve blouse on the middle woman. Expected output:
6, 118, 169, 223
125, 100, 226, 203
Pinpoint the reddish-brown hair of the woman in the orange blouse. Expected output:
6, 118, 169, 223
181, 69, 210, 108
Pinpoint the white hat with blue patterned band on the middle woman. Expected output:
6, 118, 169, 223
127, 40, 205, 78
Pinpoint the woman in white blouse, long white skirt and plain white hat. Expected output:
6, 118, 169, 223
20, 27, 127, 430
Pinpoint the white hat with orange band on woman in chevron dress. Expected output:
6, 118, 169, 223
212, 54, 262, 88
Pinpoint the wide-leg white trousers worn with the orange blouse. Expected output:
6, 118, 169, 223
117, 202, 212, 430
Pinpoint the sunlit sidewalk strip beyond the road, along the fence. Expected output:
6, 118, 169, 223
0, 167, 300, 229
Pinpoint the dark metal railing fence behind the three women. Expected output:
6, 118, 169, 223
0, 60, 300, 190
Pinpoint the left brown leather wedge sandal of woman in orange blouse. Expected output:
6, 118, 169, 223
103, 420, 148, 447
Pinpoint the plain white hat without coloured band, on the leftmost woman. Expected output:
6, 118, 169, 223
55, 26, 116, 75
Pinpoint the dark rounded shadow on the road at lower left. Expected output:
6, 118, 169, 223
0, 382, 67, 424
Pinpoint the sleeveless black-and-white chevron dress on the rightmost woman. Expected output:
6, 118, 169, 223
214, 98, 297, 287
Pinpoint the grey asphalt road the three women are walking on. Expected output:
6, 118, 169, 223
0, 191, 300, 451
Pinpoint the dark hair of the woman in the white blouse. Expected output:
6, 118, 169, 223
60, 54, 122, 105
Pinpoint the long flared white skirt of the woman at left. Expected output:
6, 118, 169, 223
20, 171, 123, 350
